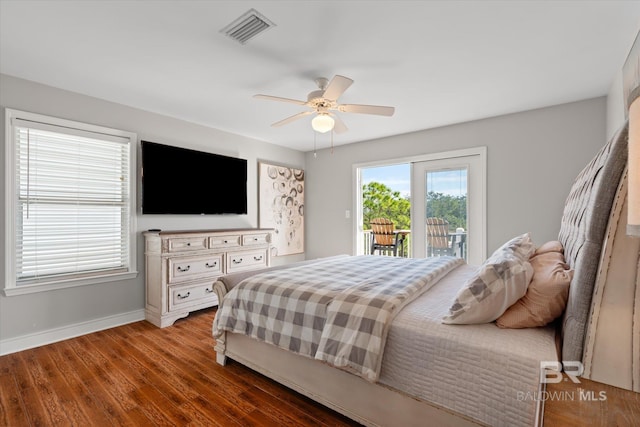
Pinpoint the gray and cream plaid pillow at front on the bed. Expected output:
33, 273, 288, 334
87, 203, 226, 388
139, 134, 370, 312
442, 233, 535, 324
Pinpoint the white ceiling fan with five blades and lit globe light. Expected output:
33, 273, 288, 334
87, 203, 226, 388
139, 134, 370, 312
253, 75, 395, 133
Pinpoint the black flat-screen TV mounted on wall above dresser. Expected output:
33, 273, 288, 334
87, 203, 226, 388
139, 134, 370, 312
141, 141, 247, 215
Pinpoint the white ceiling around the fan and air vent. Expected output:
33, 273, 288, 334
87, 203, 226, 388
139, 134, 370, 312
0, 0, 640, 151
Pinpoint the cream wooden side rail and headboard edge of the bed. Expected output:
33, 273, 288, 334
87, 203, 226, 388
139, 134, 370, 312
214, 128, 640, 426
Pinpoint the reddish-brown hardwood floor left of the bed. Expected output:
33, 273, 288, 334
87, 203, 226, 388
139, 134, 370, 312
0, 309, 359, 427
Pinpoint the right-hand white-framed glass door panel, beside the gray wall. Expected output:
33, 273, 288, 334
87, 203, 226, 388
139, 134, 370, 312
411, 147, 486, 265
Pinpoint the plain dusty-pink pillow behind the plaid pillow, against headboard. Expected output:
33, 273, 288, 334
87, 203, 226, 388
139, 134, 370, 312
496, 241, 573, 328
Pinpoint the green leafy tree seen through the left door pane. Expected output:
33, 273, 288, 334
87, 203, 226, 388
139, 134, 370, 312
362, 181, 411, 230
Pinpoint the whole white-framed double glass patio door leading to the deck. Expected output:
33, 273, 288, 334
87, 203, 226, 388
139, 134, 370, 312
356, 147, 486, 265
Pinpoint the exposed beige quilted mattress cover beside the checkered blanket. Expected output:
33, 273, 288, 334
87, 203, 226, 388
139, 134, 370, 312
379, 265, 557, 426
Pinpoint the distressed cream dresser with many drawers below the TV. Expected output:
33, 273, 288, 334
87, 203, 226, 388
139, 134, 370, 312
144, 228, 273, 328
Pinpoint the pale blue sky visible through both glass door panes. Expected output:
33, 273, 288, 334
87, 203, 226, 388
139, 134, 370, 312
362, 163, 467, 197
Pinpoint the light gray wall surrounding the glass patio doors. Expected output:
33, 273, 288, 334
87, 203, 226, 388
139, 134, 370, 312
305, 97, 607, 258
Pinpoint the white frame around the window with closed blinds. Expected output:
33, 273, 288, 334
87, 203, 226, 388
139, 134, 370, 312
1, 108, 138, 296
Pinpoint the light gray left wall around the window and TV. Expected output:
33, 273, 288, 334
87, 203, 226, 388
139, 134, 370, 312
0, 75, 305, 344
